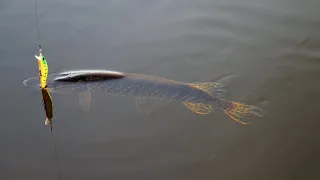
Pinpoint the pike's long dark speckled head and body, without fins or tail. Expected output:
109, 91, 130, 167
52, 71, 218, 103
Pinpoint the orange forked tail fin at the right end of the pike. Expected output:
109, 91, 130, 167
224, 101, 265, 124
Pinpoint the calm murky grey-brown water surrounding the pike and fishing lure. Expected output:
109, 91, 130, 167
0, 0, 320, 180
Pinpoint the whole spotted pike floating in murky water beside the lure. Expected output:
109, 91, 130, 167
23, 70, 265, 124
